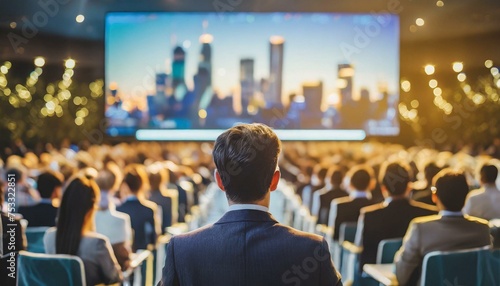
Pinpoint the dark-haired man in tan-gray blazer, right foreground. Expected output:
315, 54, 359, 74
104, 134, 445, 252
394, 169, 491, 285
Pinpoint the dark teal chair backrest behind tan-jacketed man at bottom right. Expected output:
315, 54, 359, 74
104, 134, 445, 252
420, 246, 498, 286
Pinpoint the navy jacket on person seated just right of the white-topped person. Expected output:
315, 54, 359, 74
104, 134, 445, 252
116, 199, 157, 252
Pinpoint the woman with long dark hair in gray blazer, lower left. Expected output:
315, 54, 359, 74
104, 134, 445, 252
43, 176, 122, 285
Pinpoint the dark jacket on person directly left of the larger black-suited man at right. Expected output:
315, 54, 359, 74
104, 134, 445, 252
328, 197, 375, 240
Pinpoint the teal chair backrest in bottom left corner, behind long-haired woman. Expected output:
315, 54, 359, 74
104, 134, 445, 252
17, 251, 86, 286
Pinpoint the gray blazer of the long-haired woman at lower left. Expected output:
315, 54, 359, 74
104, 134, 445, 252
43, 227, 122, 285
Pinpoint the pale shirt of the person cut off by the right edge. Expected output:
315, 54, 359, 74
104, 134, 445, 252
463, 184, 500, 220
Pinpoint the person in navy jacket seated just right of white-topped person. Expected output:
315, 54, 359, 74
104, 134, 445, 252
116, 164, 161, 252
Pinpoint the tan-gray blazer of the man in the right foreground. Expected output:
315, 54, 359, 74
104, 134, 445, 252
394, 215, 491, 285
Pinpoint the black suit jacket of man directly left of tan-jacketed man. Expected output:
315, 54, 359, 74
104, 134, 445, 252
356, 199, 437, 269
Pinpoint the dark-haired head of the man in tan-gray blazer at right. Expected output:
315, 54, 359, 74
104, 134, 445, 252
433, 169, 469, 212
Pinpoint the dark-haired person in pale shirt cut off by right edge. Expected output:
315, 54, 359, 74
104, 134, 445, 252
464, 164, 500, 220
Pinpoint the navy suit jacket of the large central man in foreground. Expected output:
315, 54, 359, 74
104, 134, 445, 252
159, 210, 342, 286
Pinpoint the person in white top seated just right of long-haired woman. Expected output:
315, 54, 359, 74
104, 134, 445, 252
95, 169, 132, 270
